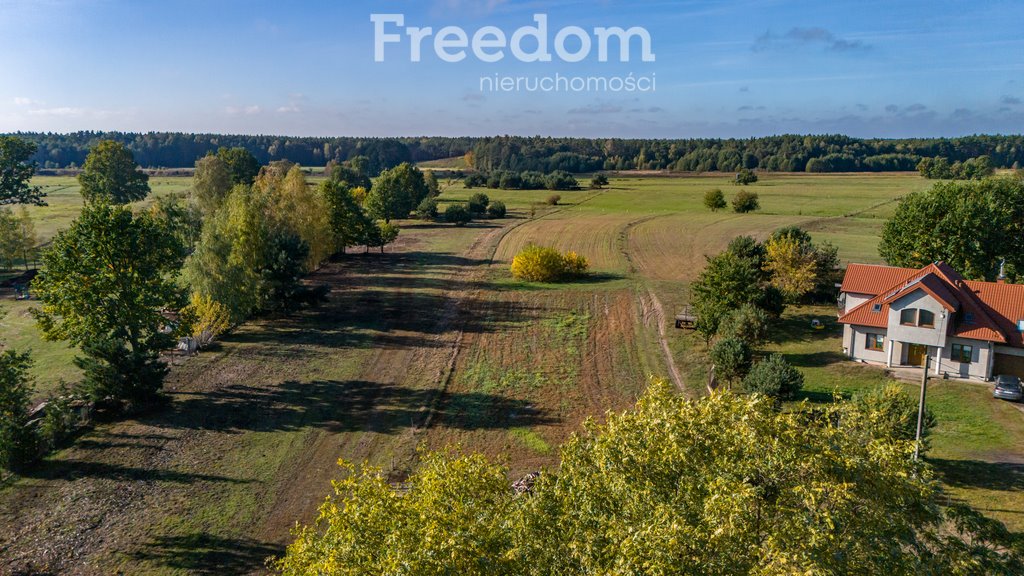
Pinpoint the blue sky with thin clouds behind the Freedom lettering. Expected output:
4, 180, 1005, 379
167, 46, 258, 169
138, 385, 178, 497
0, 0, 1024, 138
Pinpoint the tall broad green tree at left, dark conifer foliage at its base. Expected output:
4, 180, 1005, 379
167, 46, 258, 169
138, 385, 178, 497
33, 203, 184, 404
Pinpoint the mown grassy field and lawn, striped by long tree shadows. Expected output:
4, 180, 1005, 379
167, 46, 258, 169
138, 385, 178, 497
0, 174, 1024, 574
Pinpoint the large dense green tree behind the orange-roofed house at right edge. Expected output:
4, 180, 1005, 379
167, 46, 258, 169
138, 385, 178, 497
879, 176, 1024, 280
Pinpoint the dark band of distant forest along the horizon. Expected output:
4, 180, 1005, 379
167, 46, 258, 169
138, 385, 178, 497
8, 131, 1024, 173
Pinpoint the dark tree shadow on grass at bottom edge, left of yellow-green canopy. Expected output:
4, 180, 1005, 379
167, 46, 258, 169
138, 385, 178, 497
130, 532, 285, 576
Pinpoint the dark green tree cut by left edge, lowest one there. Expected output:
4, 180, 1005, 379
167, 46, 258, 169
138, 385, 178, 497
0, 351, 37, 469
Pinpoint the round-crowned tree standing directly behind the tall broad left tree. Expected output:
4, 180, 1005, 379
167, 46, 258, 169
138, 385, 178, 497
78, 140, 150, 204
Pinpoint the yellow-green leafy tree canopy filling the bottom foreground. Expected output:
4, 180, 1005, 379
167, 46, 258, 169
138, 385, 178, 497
276, 383, 1024, 575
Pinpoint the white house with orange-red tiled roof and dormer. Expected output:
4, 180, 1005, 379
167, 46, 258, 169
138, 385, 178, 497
839, 262, 1024, 380
